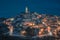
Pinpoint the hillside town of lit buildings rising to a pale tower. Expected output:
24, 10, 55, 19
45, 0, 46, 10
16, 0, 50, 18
1, 7, 60, 37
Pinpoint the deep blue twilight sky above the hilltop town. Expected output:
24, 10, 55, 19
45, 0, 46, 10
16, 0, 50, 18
0, 0, 60, 17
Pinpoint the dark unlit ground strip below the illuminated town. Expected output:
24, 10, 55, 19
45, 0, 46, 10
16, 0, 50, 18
0, 35, 60, 40
